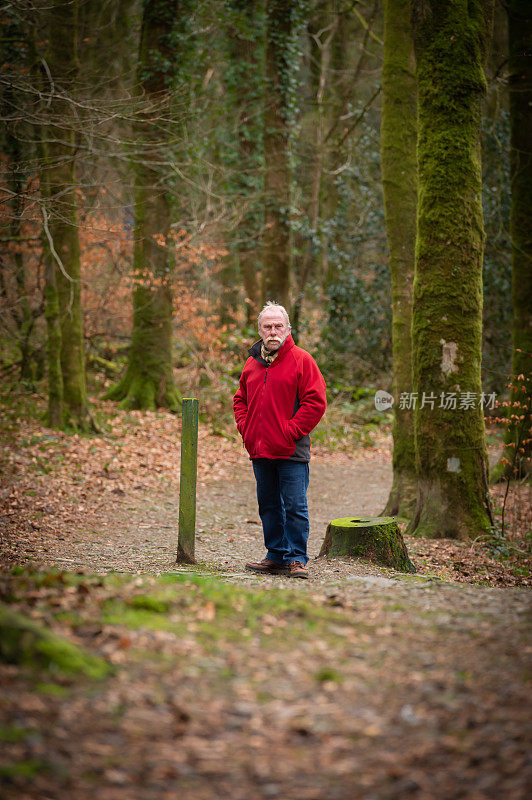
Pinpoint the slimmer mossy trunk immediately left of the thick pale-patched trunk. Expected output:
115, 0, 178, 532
381, 0, 417, 517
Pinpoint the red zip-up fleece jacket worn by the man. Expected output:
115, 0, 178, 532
233, 336, 327, 461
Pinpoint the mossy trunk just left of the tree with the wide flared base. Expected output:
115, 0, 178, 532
45, 0, 88, 429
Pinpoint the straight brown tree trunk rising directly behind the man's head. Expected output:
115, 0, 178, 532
262, 0, 297, 306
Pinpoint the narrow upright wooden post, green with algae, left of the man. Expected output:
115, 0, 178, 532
177, 397, 198, 564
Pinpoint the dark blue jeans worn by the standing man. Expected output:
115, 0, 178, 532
252, 458, 309, 564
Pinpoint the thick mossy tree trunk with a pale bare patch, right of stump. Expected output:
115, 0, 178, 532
409, 0, 492, 539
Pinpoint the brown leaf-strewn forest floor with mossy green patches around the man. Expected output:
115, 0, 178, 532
0, 406, 532, 800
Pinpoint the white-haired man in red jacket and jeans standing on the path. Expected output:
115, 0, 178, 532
233, 302, 327, 578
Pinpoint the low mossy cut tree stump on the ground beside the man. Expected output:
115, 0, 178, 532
320, 517, 416, 572
